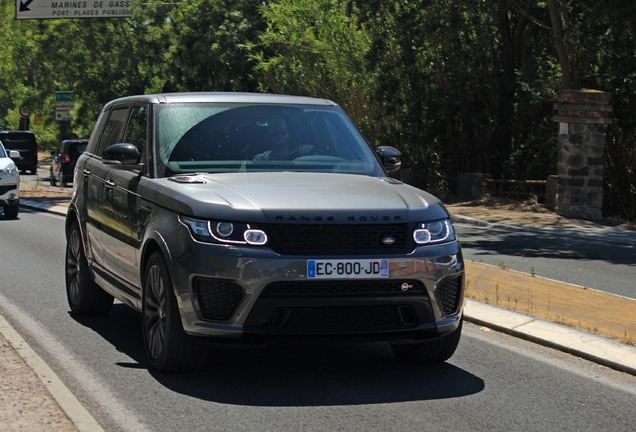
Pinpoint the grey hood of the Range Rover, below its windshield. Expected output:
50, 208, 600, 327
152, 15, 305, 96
147, 172, 448, 223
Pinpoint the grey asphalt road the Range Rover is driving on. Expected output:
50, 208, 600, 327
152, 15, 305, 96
0, 209, 636, 432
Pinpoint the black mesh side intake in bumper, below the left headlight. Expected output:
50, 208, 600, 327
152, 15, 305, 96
194, 278, 243, 321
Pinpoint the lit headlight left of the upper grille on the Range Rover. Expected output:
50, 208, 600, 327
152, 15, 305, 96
179, 216, 268, 246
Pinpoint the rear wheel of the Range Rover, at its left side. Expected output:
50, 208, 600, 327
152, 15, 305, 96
65, 221, 113, 315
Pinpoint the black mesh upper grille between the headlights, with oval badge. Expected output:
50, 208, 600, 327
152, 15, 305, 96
268, 223, 412, 255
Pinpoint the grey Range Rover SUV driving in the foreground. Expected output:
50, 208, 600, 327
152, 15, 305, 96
65, 93, 465, 372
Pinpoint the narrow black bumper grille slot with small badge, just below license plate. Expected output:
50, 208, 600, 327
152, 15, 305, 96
261, 279, 425, 298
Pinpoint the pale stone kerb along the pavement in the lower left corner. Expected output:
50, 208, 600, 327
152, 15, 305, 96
0, 315, 104, 432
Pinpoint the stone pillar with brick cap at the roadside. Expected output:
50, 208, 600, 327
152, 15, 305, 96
554, 90, 612, 220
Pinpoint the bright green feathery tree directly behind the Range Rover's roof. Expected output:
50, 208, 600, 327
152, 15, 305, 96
249, 0, 379, 132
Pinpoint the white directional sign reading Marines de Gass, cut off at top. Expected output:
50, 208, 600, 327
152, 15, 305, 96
15, 0, 133, 19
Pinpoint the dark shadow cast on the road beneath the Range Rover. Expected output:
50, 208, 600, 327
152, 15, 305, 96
73, 304, 485, 407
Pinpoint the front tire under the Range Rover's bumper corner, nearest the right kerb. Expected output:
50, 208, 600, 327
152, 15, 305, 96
391, 318, 464, 364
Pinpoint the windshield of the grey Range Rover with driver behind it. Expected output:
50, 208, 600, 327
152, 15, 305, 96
155, 103, 385, 177
